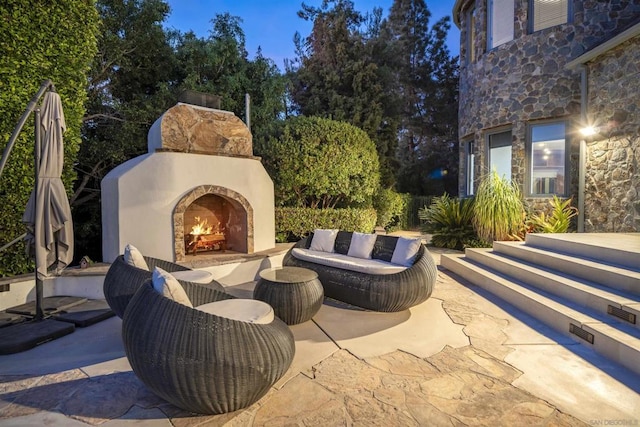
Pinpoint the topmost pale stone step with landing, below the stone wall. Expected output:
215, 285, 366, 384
525, 233, 640, 272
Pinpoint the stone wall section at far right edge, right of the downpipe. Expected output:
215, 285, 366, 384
585, 36, 640, 232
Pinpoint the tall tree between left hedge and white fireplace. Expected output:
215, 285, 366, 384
71, 0, 179, 260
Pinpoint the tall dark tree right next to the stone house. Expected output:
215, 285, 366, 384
382, 0, 458, 194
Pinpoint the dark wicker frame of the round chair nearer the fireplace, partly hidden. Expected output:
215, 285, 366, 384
103, 255, 224, 318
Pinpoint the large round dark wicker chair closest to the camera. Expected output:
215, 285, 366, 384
122, 280, 295, 414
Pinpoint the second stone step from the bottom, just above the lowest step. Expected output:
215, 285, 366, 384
465, 249, 640, 329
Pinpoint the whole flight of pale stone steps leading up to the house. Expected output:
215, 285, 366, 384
441, 233, 640, 374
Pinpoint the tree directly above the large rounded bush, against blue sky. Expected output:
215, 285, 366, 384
287, 0, 393, 185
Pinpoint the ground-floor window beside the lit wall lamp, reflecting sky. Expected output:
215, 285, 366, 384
527, 122, 567, 196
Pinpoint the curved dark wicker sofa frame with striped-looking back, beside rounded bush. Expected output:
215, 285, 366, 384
283, 231, 437, 312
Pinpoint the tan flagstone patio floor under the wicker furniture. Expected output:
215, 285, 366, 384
0, 250, 640, 427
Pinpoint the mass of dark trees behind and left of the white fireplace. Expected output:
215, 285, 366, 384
73, 5, 285, 259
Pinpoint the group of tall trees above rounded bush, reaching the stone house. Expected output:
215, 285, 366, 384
287, 0, 458, 194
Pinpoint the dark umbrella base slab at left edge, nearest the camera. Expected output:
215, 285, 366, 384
0, 319, 75, 354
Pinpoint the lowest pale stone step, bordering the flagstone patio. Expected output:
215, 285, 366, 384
440, 254, 640, 374
